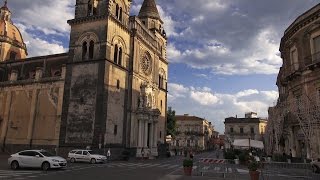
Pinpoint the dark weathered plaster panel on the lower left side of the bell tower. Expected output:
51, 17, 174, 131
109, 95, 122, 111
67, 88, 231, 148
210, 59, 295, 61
65, 64, 99, 145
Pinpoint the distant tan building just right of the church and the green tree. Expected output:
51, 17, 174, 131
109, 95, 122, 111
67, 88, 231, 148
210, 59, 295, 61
171, 114, 214, 150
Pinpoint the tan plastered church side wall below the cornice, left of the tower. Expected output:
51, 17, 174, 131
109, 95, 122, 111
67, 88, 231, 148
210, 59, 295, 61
0, 81, 64, 151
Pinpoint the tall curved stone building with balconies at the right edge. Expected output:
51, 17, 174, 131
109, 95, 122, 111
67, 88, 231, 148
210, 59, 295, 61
266, 4, 320, 158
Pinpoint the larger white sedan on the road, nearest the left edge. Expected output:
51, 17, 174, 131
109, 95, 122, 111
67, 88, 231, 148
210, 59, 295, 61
8, 150, 67, 171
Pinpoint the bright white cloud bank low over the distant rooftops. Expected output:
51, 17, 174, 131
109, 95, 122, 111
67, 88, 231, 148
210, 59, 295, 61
168, 83, 278, 132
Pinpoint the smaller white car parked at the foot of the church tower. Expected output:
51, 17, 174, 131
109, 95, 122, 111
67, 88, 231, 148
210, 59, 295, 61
68, 149, 107, 164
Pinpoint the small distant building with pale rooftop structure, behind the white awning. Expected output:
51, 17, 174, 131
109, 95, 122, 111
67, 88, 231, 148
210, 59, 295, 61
224, 112, 267, 148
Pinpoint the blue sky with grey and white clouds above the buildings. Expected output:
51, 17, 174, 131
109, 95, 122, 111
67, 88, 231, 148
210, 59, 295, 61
8, 0, 319, 133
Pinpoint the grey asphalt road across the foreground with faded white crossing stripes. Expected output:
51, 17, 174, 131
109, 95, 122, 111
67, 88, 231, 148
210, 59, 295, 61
0, 151, 320, 180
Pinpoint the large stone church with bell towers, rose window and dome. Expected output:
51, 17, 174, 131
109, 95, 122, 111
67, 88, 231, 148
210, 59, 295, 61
0, 0, 168, 157
